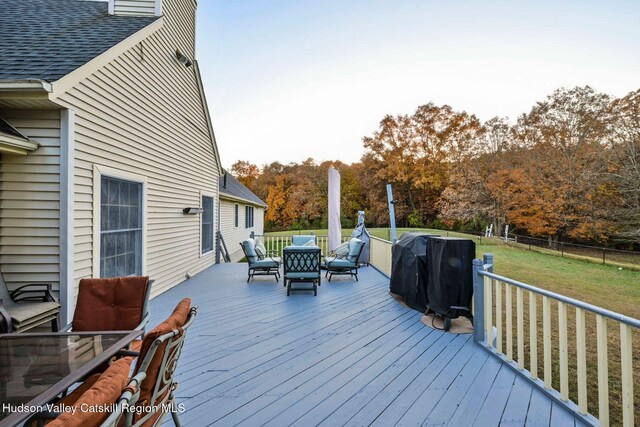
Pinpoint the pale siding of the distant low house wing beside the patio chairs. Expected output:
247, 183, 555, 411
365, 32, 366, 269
220, 198, 264, 262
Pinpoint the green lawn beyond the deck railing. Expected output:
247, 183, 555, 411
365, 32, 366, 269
268, 228, 640, 318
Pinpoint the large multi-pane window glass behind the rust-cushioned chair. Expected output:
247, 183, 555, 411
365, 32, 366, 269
100, 176, 142, 278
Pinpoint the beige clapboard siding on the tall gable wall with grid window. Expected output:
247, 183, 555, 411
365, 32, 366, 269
54, 0, 218, 296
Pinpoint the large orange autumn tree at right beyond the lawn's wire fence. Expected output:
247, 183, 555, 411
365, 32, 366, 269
510, 86, 616, 240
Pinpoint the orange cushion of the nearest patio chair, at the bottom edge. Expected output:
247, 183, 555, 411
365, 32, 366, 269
47, 357, 133, 427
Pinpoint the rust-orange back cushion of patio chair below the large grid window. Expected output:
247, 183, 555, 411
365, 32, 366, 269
72, 276, 149, 332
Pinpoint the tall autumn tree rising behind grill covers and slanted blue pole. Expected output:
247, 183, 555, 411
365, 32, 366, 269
362, 103, 482, 226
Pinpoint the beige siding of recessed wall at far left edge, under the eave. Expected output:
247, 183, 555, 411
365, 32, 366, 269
0, 110, 60, 288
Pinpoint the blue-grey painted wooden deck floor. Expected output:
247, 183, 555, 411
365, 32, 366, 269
151, 264, 582, 427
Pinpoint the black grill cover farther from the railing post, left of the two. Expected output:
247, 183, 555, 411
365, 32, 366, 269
389, 233, 436, 312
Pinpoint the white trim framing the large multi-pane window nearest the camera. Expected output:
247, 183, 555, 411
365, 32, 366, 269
92, 164, 147, 277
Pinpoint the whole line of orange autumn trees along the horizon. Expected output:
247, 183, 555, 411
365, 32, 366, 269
231, 86, 640, 247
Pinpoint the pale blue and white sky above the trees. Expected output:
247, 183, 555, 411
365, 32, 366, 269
196, 0, 640, 168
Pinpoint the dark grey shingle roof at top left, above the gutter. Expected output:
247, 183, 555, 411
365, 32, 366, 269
0, 0, 158, 82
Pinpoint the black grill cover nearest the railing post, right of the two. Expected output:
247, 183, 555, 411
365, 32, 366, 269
427, 237, 476, 318
